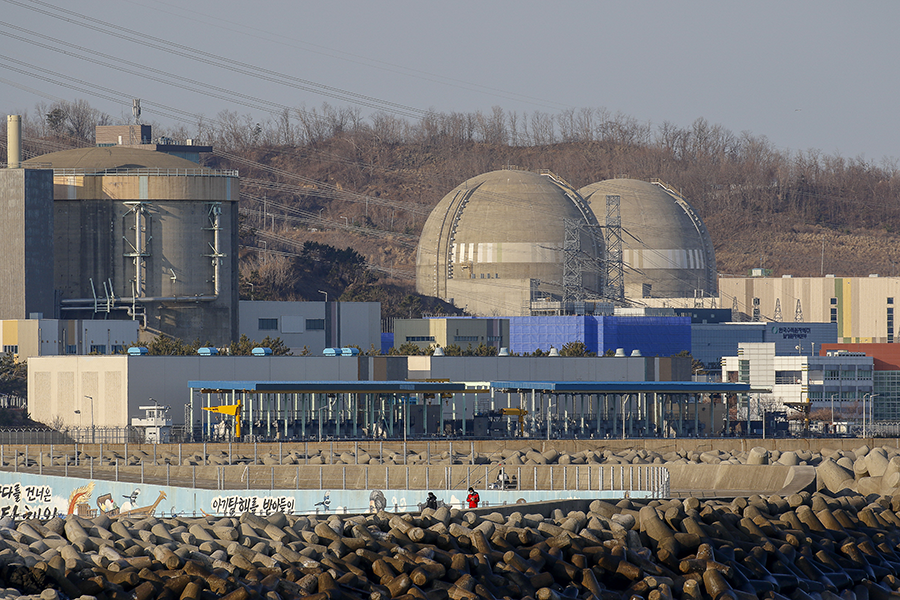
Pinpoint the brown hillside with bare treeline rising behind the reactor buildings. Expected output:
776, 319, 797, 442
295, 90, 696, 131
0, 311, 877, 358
8, 102, 900, 316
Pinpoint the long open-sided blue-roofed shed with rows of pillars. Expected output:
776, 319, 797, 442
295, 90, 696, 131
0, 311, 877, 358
188, 380, 755, 439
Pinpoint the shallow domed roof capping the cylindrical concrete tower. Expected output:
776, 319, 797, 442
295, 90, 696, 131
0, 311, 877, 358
24, 146, 203, 172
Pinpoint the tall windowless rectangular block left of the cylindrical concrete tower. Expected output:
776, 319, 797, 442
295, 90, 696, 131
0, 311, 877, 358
0, 169, 54, 319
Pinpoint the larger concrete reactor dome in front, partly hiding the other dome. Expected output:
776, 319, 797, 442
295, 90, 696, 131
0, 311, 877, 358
416, 169, 602, 316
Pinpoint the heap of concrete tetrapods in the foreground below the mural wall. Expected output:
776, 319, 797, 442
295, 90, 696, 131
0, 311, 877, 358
0, 490, 900, 600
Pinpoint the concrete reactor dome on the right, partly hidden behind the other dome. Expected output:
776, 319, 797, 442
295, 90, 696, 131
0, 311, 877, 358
579, 179, 716, 298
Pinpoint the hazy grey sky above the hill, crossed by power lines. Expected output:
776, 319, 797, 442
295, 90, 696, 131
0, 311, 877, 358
0, 0, 900, 162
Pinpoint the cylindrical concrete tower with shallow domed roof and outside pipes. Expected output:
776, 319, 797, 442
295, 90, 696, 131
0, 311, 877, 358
28, 146, 239, 345
